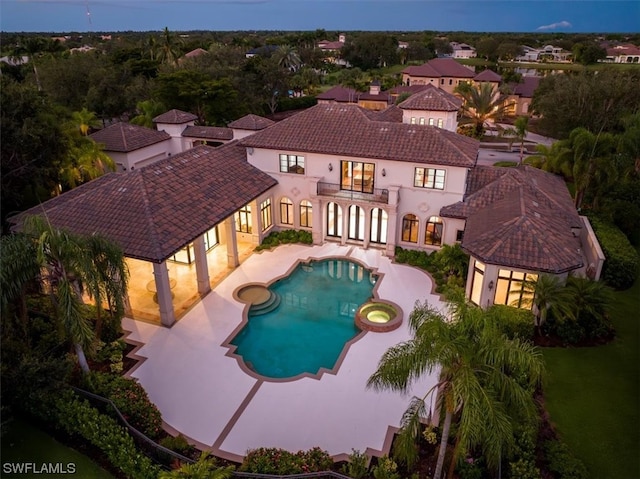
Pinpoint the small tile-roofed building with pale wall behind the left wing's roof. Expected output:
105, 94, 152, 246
89, 122, 172, 171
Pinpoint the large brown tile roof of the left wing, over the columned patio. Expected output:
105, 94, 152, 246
13, 142, 277, 262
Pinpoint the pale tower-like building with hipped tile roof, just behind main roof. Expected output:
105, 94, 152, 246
398, 85, 462, 132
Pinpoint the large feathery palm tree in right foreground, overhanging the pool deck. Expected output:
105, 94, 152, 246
368, 301, 544, 479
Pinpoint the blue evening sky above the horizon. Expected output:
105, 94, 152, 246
0, 0, 640, 33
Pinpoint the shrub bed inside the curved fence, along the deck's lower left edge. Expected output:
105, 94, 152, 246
85, 372, 162, 439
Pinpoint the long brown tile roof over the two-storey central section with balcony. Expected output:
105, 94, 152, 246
240, 104, 479, 167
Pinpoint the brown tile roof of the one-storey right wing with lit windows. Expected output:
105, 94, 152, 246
440, 166, 583, 274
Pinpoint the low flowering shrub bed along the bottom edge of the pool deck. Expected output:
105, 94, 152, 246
238, 447, 333, 475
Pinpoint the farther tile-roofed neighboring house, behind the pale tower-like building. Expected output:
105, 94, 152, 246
402, 58, 476, 93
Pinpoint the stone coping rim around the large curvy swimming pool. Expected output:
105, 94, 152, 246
225, 253, 384, 383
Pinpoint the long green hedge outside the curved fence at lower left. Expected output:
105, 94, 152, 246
53, 392, 159, 479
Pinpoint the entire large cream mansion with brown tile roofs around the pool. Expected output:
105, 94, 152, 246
16, 104, 603, 326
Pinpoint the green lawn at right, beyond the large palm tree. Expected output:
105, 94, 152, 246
543, 279, 640, 479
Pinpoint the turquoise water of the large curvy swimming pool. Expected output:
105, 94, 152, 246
230, 259, 377, 379
